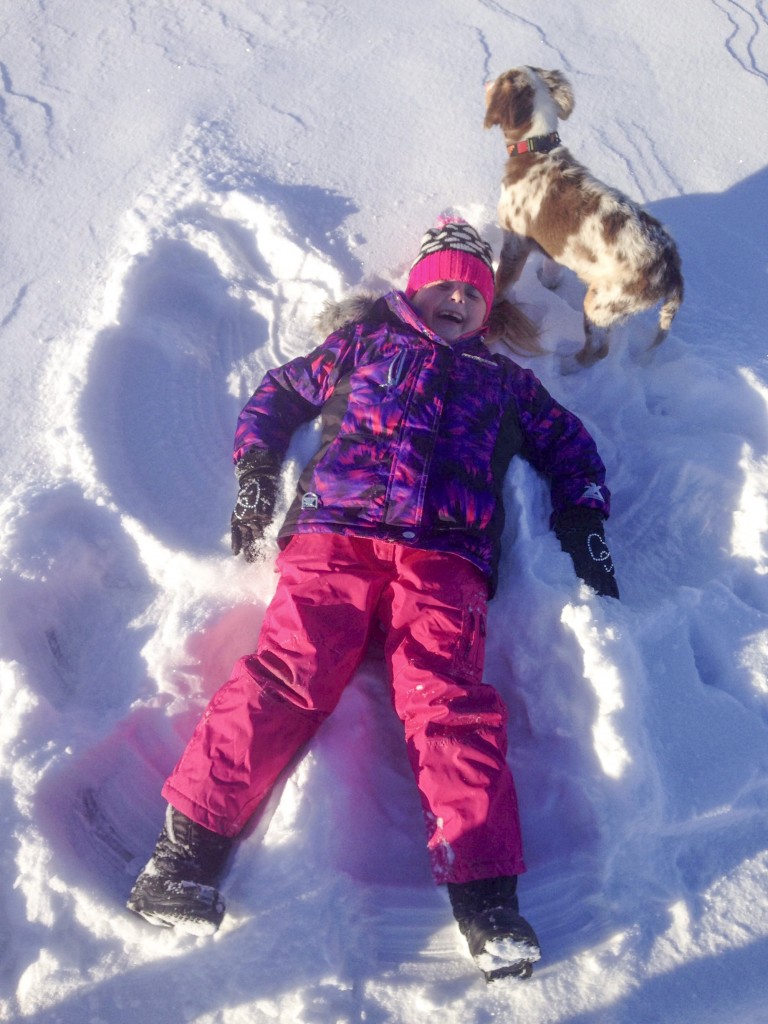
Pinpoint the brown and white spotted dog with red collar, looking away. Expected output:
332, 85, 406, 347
485, 67, 683, 366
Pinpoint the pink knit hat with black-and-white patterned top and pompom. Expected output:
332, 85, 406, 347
406, 217, 494, 316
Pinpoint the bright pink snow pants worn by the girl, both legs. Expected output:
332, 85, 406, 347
163, 534, 525, 883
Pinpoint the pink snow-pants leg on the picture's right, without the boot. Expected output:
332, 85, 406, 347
383, 546, 525, 883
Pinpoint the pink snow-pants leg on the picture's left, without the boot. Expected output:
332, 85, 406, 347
163, 535, 386, 836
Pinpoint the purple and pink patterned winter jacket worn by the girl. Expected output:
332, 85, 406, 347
234, 292, 609, 589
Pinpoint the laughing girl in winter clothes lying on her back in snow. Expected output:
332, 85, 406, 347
128, 219, 618, 980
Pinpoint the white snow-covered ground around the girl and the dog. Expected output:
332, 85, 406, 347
0, 0, 768, 1024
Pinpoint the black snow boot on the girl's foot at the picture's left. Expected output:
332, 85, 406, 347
127, 805, 233, 935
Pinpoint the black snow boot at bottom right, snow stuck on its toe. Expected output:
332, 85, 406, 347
447, 874, 542, 981
